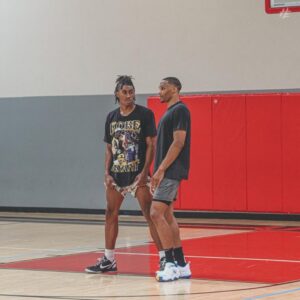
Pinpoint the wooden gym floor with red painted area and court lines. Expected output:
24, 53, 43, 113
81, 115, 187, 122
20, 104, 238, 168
0, 212, 300, 300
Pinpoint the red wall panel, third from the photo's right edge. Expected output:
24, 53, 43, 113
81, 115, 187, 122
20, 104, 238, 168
212, 95, 247, 211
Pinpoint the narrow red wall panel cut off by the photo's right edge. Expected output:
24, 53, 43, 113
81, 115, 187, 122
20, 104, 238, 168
282, 94, 300, 213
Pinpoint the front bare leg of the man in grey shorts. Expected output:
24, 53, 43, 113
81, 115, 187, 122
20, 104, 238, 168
150, 201, 174, 249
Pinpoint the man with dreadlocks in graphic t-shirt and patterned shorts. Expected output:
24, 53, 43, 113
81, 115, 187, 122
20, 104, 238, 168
85, 76, 162, 273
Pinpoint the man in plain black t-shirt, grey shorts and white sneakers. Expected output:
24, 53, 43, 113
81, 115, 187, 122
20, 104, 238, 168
151, 77, 191, 282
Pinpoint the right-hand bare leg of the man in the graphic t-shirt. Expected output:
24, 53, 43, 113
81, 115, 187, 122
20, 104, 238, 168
136, 186, 162, 251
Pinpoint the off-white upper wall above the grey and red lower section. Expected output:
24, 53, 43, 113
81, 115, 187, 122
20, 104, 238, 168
0, 0, 300, 97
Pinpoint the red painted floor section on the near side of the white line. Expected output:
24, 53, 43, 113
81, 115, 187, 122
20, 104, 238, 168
1, 253, 300, 283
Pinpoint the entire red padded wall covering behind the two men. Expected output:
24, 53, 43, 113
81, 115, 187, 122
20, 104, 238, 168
148, 94, 300, 213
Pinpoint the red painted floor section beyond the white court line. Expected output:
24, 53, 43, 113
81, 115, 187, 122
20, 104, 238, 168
118, 230, 300, 260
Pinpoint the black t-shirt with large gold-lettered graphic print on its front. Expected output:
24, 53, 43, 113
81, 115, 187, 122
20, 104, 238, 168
104, 105, 156, 187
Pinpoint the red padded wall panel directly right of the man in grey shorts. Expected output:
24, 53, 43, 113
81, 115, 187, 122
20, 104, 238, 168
181, 96, 213, 210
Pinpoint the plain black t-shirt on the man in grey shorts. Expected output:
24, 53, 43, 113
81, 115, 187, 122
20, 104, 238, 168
154, 101, 191, 180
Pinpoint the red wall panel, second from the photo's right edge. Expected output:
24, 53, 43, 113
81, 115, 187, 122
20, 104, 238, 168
246, 94, 282, 212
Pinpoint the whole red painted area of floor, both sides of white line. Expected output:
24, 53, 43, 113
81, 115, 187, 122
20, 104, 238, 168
0, 231, 300, 283
